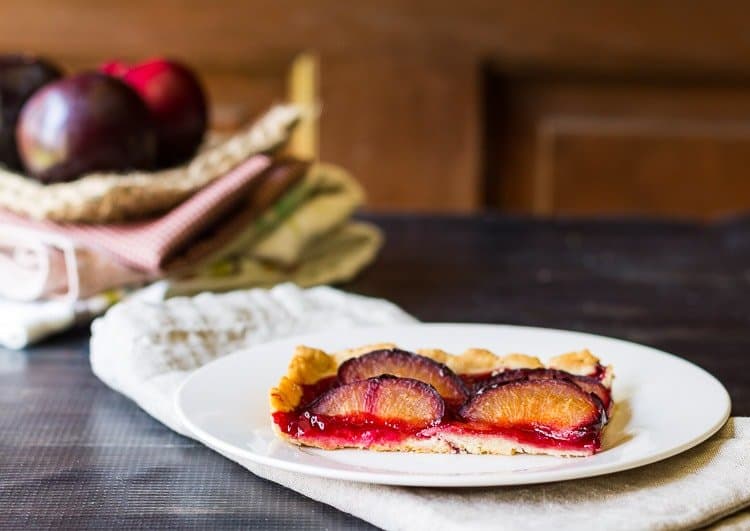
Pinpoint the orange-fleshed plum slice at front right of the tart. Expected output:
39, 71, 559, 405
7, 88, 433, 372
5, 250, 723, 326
459, 379, 602, 433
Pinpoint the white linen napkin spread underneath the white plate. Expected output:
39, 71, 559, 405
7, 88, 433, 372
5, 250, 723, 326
91, 284, 750, 531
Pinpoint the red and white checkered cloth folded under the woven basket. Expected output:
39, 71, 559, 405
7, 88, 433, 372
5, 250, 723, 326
0, 155, 272, 273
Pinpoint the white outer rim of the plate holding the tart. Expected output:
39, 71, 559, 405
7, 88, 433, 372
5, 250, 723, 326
173, 322, 732, 487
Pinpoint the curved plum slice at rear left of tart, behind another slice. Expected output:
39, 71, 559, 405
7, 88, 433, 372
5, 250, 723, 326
338, 349, 469, 405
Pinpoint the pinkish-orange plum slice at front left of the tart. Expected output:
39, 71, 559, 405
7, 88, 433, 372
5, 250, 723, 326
308, 376, 445, 428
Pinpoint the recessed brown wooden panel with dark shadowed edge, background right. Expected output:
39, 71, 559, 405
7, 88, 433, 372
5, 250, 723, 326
485, 74, 750, 217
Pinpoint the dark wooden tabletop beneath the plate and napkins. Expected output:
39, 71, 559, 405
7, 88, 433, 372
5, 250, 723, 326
0, 216, 750, 529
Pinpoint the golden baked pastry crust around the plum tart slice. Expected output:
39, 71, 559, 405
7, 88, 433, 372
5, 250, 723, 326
270, 343, 614, 456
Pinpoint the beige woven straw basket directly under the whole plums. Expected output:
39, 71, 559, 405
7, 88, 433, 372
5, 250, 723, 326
0, 105, 303, 223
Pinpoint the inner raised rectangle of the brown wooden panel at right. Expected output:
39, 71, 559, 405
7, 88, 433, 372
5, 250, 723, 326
535, 119, 750, 217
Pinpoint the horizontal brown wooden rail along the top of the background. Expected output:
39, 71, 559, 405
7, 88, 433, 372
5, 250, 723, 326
0, 0, 750, 75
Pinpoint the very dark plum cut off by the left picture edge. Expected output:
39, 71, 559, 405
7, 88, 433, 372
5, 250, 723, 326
0, 54, 62, 171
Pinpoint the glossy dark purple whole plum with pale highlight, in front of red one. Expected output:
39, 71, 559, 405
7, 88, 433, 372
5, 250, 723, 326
16, 72, 156, 183
